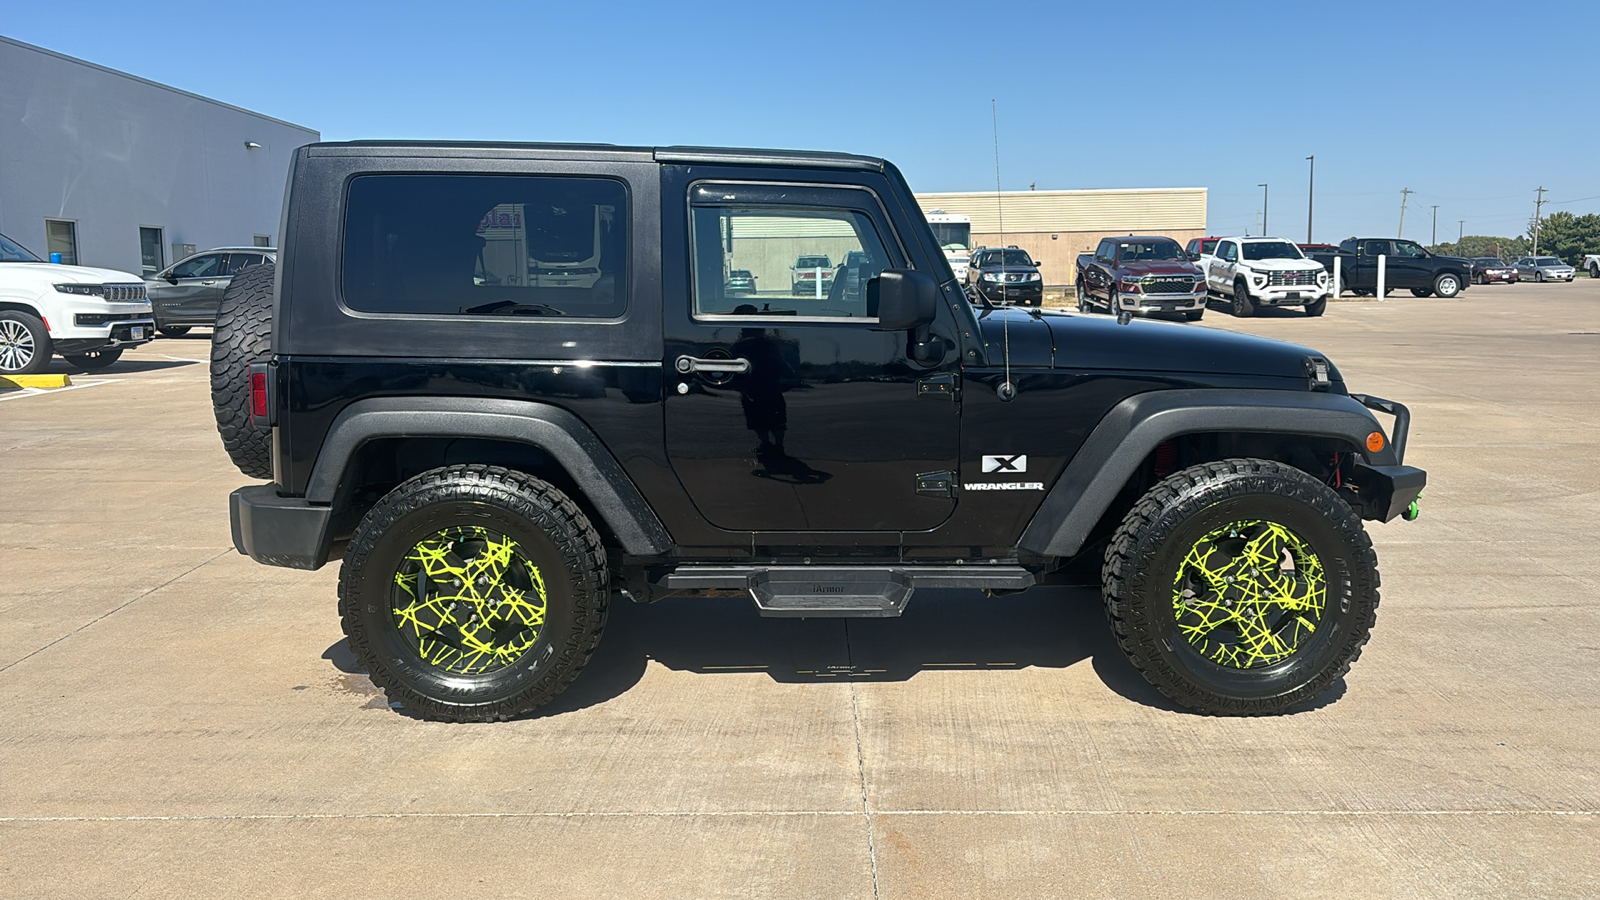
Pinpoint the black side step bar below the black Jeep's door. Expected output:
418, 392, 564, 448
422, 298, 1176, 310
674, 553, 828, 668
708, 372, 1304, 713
654, 565, 1034, 618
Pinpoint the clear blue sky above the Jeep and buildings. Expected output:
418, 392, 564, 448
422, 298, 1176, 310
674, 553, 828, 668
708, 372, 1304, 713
0, 0, 1600, 242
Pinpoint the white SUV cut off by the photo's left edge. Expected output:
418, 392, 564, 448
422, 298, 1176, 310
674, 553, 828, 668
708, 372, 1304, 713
0, 234, 155, 375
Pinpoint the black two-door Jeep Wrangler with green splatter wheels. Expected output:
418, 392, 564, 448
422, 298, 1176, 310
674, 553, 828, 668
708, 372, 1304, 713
211, 143, 1424, 721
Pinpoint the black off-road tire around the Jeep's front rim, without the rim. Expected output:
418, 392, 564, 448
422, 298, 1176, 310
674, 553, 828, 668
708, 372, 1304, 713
1101, 460, 1378, 716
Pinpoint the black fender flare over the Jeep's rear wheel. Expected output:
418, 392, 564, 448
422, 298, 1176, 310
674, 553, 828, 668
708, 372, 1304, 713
306, 397, 674, 556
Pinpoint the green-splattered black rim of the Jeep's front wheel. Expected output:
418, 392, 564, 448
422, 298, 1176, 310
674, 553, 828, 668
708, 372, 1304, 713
1173, 519, 1328, 669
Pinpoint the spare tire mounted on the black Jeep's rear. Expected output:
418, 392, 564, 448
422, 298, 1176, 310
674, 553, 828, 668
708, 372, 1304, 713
211, 263, 277, 479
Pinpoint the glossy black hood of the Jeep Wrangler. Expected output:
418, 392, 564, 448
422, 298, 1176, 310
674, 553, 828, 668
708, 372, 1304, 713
978, 309, 1342, 381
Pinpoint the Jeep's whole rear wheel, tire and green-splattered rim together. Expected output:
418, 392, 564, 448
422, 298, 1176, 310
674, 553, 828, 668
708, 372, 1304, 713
339, 466, 608, 722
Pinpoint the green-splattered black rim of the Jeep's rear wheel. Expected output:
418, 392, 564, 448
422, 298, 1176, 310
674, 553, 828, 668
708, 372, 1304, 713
390, 525, 549, 676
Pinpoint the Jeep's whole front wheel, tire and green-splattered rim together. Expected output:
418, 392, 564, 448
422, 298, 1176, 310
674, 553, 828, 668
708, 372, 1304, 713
1101, 460, 1378, 716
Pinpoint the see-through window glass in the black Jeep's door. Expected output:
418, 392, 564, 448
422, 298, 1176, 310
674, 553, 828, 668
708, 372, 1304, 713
693, 205, 890, 319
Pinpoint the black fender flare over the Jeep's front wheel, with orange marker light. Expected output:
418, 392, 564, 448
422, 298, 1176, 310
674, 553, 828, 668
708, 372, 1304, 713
1018, 389, 1400, 557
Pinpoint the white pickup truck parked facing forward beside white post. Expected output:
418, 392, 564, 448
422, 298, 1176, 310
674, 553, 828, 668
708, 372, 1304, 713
1195, 237, 1333, 315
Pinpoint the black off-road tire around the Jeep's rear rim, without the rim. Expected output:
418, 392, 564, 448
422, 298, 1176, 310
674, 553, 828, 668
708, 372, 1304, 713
339, 464, 610, 722
